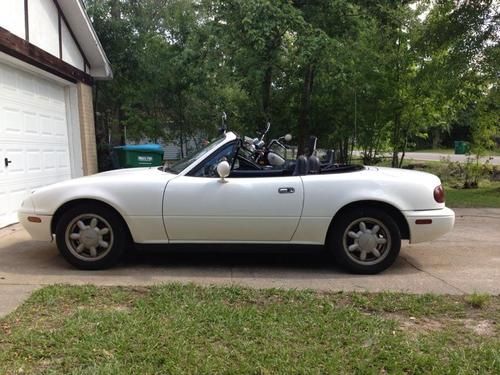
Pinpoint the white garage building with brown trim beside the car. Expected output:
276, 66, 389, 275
0, 0, 112, 228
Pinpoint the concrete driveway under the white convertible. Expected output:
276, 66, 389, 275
0, 209, 500, 315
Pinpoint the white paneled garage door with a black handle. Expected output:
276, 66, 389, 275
0, 63, 71, 228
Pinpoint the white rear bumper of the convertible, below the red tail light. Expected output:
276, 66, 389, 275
403, 207, 455, 243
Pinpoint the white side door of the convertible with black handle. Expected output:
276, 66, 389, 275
163, 176, 304, 242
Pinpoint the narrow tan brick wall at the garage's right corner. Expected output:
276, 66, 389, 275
77, 82, 97, 176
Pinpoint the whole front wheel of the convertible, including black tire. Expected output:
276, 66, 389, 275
56, 203, 129, 270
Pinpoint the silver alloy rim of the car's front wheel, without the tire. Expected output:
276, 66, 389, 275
64, 213, 113, 262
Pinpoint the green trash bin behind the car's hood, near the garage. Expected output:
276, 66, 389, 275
114, 143, 163, 168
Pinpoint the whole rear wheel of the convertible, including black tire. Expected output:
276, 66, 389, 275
327, 207, 401, 274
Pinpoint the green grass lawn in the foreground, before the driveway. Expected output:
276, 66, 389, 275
0, 284, 500, 374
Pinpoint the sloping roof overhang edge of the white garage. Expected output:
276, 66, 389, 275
58, 0, 113, 79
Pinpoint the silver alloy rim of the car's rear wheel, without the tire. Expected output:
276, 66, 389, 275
342, 217, 391, 266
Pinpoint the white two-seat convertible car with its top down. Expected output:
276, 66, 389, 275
19, 132, 455, 273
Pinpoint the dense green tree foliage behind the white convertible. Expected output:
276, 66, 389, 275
85, 0, 500, 170
